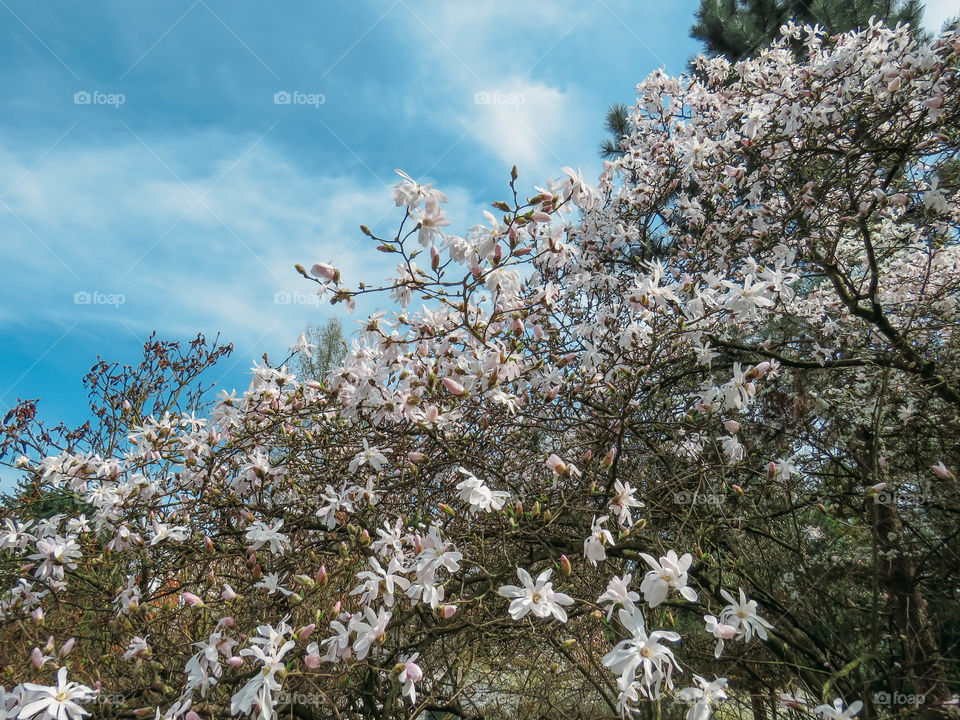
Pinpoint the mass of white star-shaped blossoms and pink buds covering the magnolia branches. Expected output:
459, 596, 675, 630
0, 16, 960, 720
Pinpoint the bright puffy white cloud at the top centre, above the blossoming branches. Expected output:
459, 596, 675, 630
397, 2, 600, 185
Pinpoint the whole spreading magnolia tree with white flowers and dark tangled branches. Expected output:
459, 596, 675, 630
0, 15, 960, 720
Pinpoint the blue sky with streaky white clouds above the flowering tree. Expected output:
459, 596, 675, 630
0, 0, 949, 458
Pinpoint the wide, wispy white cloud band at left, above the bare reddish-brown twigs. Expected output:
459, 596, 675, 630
0, 134, 428, 356
